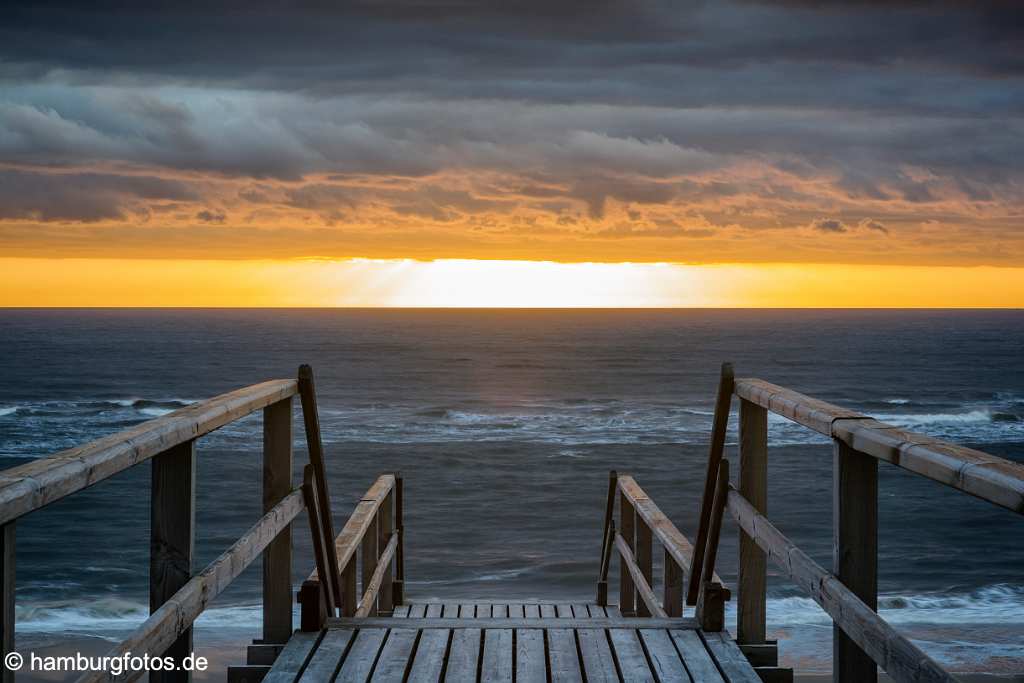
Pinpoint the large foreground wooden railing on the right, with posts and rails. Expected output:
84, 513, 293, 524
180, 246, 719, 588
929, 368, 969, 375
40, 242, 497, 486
688, 364, 1024, 683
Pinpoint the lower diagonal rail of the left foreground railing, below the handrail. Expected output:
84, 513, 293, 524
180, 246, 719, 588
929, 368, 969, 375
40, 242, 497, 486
79, 490, 304, 682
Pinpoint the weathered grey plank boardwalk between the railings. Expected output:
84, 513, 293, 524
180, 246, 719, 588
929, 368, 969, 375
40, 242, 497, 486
263, 602, 761, 683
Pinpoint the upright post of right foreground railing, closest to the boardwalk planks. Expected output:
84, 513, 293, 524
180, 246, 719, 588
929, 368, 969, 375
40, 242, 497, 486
736, 399, 768, 645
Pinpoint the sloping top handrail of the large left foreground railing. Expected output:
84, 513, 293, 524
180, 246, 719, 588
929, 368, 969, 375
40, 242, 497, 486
0, 380, 296, 524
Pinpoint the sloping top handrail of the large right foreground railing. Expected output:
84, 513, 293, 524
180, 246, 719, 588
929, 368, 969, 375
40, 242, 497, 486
735, 379, 1024, 514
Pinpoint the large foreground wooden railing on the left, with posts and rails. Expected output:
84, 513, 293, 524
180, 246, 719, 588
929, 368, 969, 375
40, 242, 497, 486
0, 366, 326, 683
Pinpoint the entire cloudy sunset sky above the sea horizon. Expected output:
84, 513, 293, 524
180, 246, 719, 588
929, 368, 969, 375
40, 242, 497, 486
0, 0, 1024, 306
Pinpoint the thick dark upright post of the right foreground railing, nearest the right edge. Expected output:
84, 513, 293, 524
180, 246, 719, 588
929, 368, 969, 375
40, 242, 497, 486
833, 439, 879, 683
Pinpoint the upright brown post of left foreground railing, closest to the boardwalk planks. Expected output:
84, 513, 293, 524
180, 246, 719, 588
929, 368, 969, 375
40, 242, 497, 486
263, 396, 292, 643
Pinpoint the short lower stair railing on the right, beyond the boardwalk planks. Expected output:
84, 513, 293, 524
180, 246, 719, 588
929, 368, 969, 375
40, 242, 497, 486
597, 472, 730, 631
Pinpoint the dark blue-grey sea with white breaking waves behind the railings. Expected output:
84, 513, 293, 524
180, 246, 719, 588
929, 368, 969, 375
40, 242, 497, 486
0, 309, 1024, 680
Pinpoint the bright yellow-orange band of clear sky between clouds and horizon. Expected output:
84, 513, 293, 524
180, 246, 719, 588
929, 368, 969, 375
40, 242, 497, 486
0, 258, 1024, 307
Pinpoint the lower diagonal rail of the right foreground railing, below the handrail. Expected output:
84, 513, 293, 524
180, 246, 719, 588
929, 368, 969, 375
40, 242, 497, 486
728, 488, 955, 683
